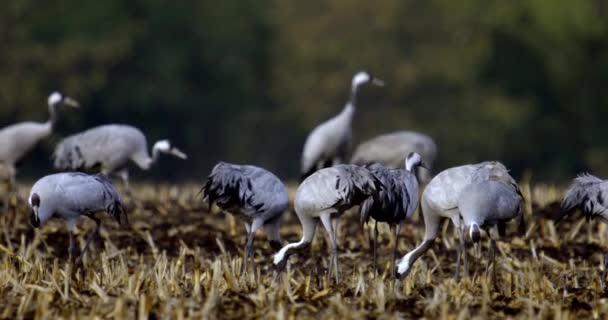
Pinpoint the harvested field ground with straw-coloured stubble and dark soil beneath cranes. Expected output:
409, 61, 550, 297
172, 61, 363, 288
0, 183, 608, 319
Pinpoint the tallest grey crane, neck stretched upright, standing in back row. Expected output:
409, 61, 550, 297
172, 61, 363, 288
300, 71, 384, 179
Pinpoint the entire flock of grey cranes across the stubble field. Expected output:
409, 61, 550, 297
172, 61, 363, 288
0, 71, 608, 282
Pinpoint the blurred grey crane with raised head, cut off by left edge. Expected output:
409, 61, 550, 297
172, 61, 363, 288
0, 92, 79, 212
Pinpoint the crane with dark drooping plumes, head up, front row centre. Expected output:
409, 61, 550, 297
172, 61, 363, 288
360, 152, 426, 274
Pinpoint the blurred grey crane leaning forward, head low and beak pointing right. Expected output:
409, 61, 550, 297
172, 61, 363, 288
53, 124, 188, 190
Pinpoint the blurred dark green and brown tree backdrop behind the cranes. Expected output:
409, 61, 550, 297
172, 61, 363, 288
0, 0, 608, 182
